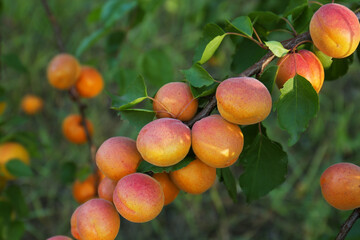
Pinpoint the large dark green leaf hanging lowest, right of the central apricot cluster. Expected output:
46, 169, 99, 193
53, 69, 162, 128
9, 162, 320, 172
239, 134, 287, 202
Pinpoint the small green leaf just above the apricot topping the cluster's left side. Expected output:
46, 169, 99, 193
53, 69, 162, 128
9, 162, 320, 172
181, 63, 215, 88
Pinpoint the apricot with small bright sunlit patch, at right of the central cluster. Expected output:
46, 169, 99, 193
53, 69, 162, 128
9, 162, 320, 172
191, 115, 244, 168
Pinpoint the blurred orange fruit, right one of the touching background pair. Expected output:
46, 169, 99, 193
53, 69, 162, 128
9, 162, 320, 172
75, 66, 104, 98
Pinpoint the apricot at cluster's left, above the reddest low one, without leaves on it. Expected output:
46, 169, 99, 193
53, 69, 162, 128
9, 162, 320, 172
96, 137, 141, 181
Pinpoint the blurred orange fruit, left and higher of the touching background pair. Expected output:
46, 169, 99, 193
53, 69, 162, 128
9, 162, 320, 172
47, 53, 81, 90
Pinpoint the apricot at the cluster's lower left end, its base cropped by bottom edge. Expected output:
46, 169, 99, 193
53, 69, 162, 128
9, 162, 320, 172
76, 199, 120, 240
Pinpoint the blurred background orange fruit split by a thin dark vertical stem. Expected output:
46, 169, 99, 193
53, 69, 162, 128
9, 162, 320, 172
62, 114, 94, 144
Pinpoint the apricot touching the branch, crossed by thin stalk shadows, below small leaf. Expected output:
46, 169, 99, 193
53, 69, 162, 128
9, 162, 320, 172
153, 82, 198, 121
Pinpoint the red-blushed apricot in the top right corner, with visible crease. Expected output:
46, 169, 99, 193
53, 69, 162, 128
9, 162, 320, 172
310, 3, 360, 58
